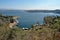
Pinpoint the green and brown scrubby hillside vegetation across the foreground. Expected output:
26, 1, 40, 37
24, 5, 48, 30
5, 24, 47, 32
0, 15, 60, 40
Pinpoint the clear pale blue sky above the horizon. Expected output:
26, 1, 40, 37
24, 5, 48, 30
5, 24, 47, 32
0, 0, 60, 10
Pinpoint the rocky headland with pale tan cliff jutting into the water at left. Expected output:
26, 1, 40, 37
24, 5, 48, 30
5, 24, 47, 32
0, 15, 18, 28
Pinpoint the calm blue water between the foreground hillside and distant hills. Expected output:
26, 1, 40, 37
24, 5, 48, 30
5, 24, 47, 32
2, 11, 60, 28
